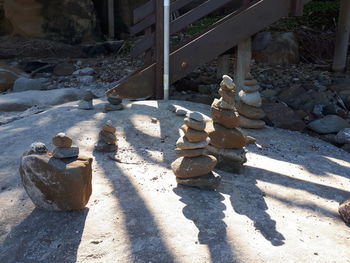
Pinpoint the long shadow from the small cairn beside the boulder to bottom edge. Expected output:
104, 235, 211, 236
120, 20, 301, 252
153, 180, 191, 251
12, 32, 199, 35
93, 151, 175, 263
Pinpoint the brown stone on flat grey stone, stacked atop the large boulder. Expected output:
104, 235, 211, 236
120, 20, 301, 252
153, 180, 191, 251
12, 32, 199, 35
52, 132, 79, 159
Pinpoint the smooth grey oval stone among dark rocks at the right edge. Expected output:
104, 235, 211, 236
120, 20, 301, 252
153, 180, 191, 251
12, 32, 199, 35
307, 115, 350, 134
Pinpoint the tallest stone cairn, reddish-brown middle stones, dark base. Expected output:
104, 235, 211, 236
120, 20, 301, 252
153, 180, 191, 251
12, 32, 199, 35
207, 75, 248, 173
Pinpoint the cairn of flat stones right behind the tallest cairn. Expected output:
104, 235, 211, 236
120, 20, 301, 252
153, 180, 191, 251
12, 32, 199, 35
236, 73, 265, 129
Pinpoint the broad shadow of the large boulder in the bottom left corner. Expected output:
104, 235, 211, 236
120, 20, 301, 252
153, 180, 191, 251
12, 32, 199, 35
0, 208, 89, 263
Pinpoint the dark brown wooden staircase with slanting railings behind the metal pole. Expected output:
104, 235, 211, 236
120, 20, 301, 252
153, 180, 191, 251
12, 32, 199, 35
106, 0, 311, 99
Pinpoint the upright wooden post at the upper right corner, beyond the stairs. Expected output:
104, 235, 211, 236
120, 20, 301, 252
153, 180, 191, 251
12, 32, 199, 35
332, 0, 350, 72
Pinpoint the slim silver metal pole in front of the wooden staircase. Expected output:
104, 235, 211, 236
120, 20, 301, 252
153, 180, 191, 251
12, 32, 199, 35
163, 0, 170, 100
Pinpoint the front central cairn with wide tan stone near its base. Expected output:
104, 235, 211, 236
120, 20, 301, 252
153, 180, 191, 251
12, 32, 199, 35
171, 112, 221, 190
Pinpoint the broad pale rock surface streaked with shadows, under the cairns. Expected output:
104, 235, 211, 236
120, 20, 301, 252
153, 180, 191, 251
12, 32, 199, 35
0, 100, 350, 263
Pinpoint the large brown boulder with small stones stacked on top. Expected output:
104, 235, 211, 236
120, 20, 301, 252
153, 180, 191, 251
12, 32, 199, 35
19, 133, 92, 211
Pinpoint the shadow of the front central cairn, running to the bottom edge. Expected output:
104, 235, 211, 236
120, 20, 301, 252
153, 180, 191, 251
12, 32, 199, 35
173, 185, 236, 262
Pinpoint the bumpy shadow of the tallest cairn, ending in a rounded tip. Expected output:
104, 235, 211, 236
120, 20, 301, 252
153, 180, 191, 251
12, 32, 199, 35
217, 171, 285, 246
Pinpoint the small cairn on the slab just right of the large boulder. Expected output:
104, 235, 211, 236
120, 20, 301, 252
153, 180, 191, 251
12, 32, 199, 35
95, 120, 118, 152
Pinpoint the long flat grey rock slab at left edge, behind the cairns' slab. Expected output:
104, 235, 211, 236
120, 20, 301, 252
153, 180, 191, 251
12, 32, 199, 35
0, 88, 81, 112
